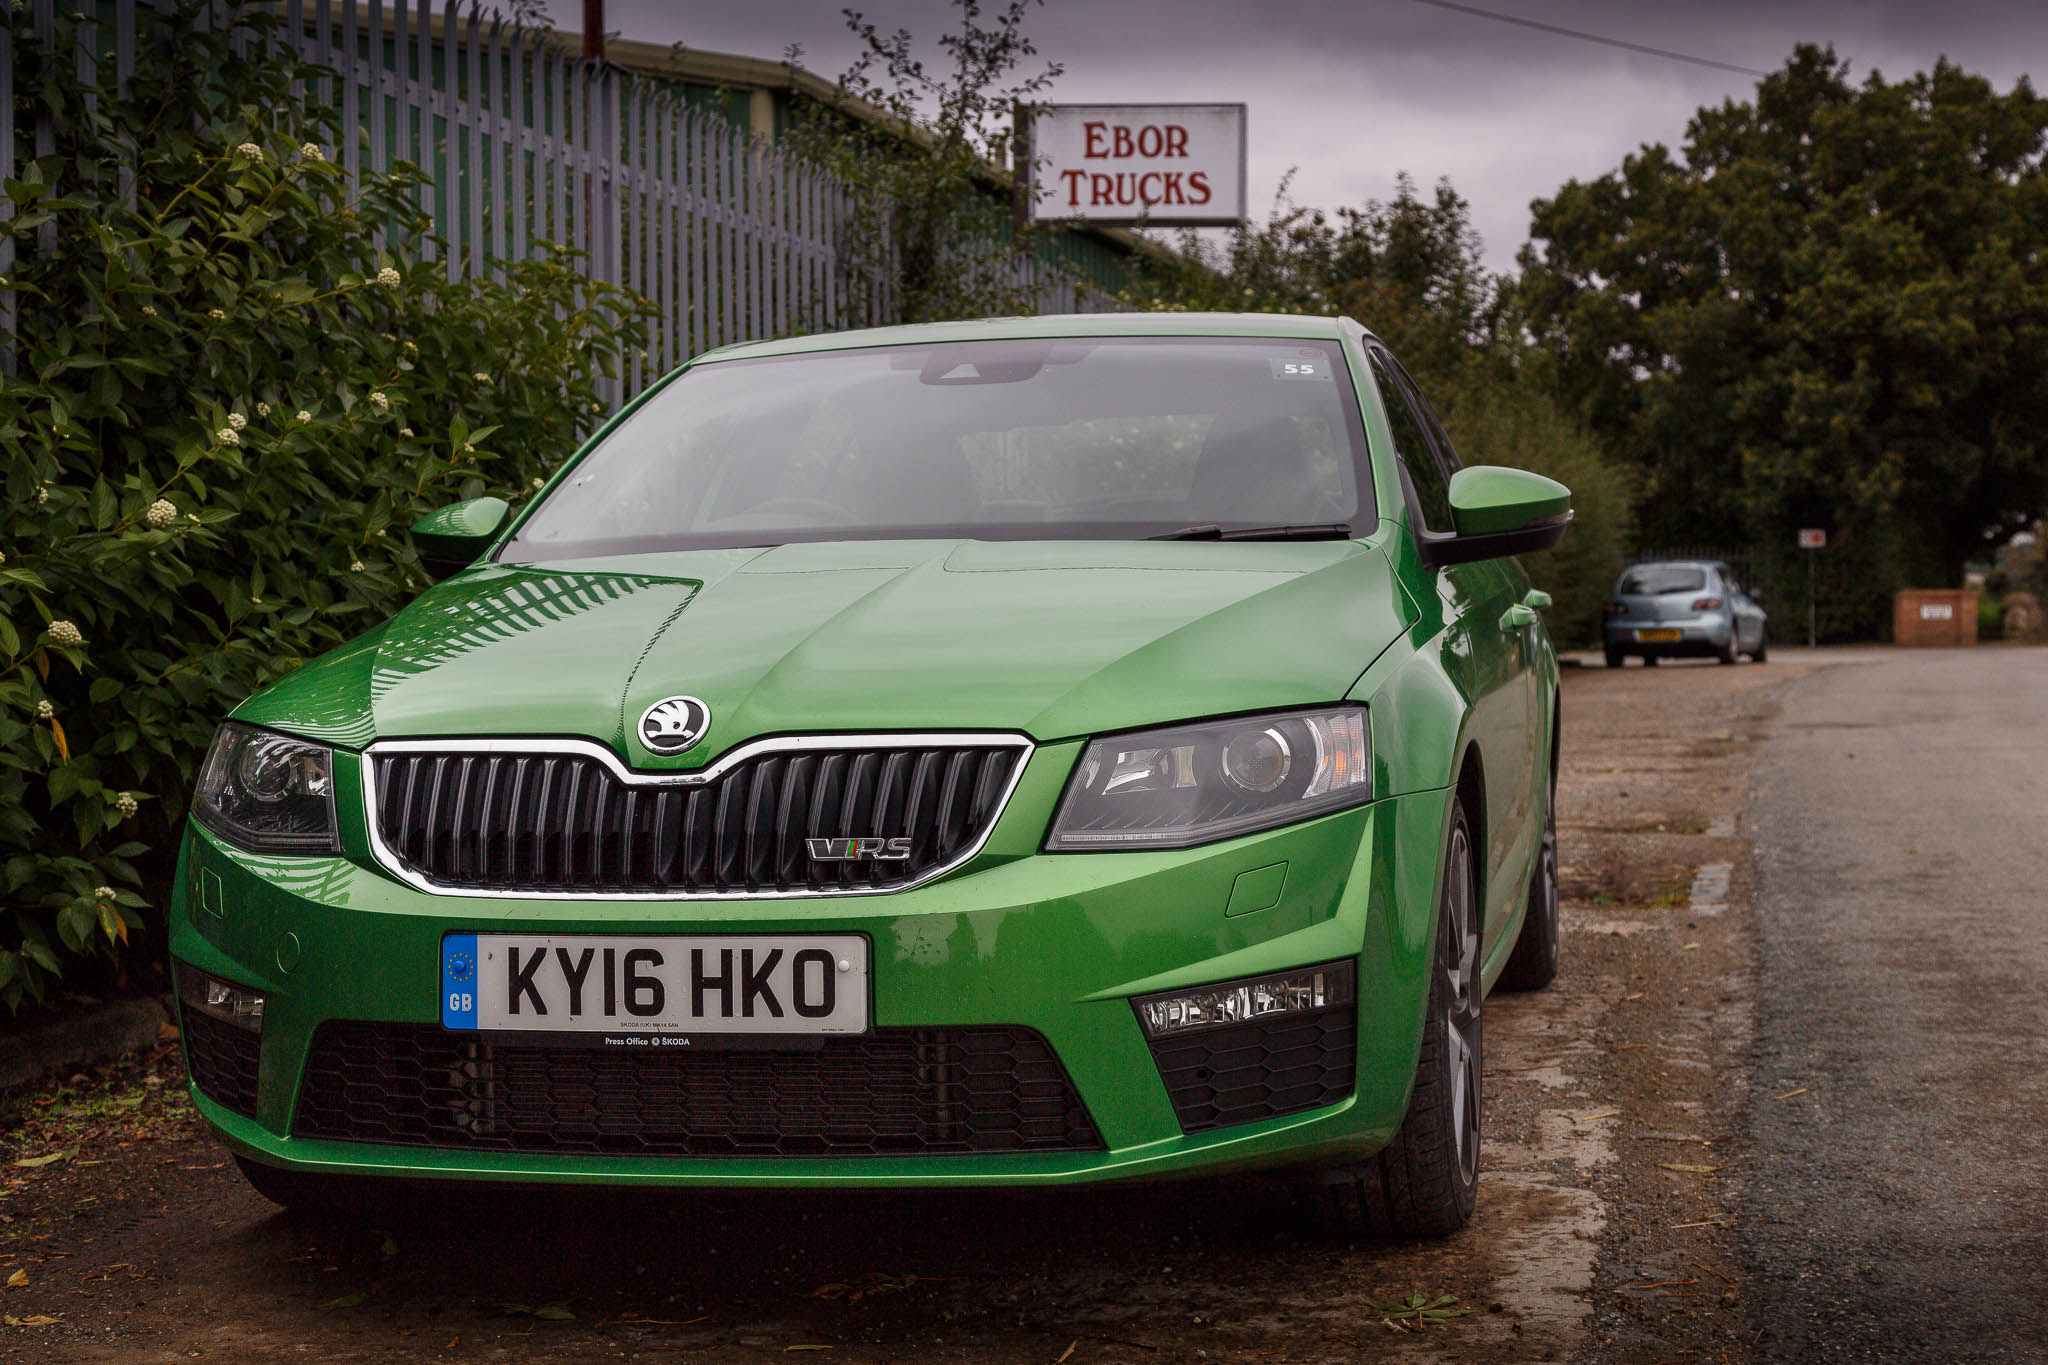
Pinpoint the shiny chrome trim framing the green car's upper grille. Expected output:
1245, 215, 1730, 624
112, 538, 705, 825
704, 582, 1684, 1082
362, 731, 1036, 900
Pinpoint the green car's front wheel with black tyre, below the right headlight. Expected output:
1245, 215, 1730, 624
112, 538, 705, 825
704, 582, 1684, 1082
1325, 796, 1485, 1238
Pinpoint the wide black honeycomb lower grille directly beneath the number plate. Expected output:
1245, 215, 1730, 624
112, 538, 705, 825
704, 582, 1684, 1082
293, 1023, 1102, 1156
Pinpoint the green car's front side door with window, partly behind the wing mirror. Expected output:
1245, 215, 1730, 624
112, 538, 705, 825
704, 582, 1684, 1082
1368, 346, 1538, 952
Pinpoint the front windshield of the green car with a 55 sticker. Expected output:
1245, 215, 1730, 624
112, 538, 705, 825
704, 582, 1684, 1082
502, 338, 1374, 561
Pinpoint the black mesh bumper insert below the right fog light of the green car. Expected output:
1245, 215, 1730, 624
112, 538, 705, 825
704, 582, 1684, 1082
1151, 1005, 1358, 1134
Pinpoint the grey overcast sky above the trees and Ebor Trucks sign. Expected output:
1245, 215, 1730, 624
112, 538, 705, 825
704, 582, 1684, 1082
549, 0, 2048, 270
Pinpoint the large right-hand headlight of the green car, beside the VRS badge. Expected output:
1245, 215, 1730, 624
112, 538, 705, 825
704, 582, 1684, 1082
1044, 706, 1372, 853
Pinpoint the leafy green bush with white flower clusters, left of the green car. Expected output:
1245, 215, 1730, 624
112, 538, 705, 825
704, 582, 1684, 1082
0, 10, 645, 1009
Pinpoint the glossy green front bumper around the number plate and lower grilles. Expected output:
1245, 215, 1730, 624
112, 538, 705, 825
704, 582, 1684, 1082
170, 745, 1446, 1185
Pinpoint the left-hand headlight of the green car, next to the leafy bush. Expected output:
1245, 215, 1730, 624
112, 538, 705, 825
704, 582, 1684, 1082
193, 722, 340, 853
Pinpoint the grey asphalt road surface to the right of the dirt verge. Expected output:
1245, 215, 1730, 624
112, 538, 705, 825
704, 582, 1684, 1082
1743, 649, 2048, 1361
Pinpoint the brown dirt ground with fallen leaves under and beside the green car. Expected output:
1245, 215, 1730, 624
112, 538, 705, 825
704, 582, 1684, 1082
0, 651, 1839, 1365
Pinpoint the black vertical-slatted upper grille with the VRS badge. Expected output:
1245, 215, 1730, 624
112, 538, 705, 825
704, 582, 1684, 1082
371, 745, 1024, 894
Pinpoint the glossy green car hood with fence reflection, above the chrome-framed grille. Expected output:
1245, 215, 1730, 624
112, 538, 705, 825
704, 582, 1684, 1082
236, 540, 1413, 767
